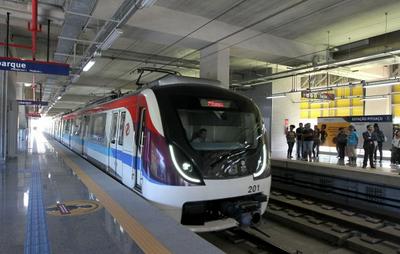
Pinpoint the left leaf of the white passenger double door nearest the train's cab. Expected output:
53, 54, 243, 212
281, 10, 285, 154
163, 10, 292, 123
107, 110, 119, 175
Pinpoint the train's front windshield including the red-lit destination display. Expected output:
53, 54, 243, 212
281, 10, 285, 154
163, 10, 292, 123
176, 98, 260, 151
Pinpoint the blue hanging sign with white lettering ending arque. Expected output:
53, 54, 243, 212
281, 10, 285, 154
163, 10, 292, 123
0, 57, 69, 76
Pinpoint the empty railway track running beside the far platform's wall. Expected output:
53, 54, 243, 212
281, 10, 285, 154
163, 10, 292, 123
265, 190, 400, 254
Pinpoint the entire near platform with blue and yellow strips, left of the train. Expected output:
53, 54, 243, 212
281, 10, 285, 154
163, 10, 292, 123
0, 133, 222, 254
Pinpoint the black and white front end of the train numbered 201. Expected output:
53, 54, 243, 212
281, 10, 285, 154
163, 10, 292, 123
147, 85, 271, 232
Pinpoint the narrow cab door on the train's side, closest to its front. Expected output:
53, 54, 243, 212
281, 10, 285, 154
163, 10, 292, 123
135, 107, 146, 191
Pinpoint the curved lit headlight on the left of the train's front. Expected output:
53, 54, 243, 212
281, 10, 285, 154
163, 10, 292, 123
169, 145, 201, 184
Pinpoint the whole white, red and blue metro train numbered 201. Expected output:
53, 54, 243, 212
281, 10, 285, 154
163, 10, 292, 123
52, 75, 271, 232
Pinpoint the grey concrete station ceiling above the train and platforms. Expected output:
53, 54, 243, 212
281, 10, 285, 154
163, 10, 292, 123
0, 0, 400, 115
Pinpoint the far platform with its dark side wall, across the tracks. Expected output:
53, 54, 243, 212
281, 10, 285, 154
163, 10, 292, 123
271, 154, 400, 220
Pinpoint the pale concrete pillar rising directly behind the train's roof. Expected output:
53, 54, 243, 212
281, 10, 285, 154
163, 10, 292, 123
200, 44, 230, 89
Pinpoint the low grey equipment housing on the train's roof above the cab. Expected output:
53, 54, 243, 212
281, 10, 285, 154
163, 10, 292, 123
149, 75, 221, 86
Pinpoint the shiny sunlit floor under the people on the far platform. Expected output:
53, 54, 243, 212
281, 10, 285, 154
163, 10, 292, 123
272, 149, 400, 175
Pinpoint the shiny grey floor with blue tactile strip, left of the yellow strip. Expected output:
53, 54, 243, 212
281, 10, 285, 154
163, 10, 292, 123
0, 132, 142, 254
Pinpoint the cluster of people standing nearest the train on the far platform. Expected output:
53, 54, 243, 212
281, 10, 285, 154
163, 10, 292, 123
286, 123, 328, 161
